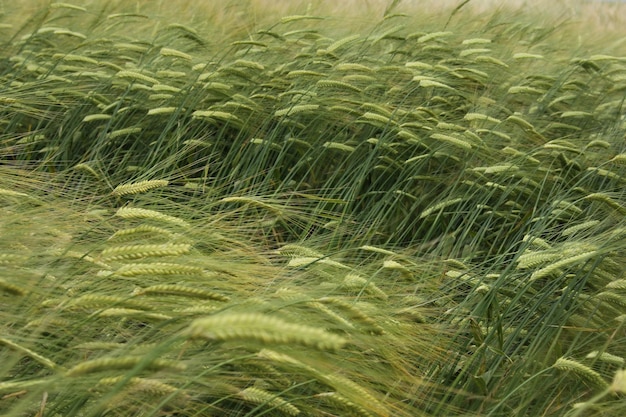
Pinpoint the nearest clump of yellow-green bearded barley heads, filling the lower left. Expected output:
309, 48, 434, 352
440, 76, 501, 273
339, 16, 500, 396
0, 167, 450, 416
